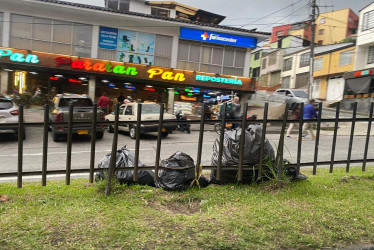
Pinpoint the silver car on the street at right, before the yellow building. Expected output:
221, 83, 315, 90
267, 89, 320, 108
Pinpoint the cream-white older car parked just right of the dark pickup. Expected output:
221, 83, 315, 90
105, 103, 177, 139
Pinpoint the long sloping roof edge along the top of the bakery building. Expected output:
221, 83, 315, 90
34, 0, 271, 36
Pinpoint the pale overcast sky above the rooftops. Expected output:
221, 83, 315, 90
65, 0, 374, 31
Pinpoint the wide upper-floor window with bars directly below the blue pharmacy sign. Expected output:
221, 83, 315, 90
177, 40, 246, 76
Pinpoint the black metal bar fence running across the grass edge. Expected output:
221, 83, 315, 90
0, 103, 374, 195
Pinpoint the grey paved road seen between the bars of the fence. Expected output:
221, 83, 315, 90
0, 108, 374, 181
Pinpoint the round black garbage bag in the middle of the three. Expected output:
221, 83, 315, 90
155, 152, 209, 191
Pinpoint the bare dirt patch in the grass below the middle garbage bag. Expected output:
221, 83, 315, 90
148, 200, 201, 215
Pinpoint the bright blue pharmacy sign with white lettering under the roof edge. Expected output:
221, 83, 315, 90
180, 28, 257, 49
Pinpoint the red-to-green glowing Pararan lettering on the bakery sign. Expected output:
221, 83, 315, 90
55, 57, 138, 76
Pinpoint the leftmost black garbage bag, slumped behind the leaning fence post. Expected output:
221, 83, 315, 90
95, 146, 155, 186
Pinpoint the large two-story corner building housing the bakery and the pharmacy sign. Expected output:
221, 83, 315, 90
0, 0, 269, 113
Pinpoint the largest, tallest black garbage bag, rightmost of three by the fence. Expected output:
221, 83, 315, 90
211, 124, 275, 183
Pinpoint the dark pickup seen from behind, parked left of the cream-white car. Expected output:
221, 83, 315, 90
50, 94, 105, 142
